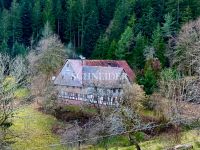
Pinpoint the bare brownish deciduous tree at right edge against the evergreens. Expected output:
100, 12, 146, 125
172, 18, 200, 75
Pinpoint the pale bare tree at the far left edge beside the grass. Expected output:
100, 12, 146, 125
0, 54, 28, 144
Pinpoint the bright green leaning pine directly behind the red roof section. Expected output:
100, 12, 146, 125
115, 26, 133, 59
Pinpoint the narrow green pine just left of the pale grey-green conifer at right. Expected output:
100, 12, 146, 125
152, 24, 166, 66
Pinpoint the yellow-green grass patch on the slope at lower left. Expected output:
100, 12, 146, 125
8, 106, 62, 150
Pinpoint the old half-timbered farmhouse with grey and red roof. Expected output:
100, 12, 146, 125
54, 59, 135, 105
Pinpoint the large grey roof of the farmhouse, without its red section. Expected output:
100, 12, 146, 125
54, 60, 134, 88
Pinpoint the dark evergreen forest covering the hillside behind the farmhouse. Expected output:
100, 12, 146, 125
0, 0, 200, 70
